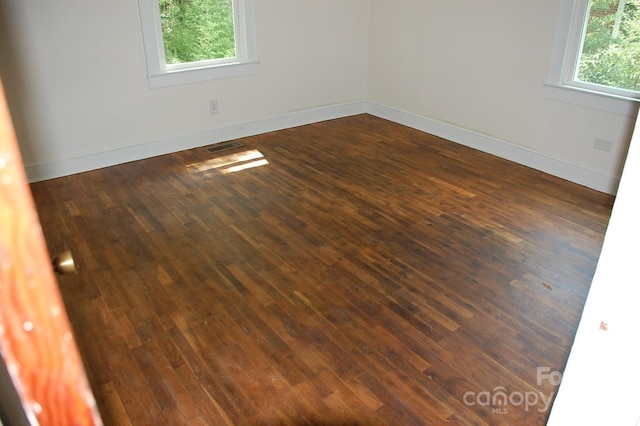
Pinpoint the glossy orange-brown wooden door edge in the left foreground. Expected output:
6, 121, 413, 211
0, 82, 101, 425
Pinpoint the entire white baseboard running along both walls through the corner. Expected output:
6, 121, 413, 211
25, 101, 619, 194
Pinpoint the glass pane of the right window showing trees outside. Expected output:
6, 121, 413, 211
576, 0, 640, 91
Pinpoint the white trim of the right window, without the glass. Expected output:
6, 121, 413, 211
545, 0, 640, 117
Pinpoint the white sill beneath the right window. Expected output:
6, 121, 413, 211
544, 83, 640, 117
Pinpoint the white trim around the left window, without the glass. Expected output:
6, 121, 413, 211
138, 0, 258, 88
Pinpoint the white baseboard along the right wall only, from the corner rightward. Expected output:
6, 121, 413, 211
367, 102, 620, 194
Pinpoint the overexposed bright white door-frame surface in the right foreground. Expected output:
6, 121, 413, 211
548, 103, 640, 426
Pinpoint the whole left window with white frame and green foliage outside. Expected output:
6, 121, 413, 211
138, 0, 257, 87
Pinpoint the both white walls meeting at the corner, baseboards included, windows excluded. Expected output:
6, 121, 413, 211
0, 0, 633, 192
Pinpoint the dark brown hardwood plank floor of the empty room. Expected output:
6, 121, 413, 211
32, 115, 613, 425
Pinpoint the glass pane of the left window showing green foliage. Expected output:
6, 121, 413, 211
159, 0, 236, 64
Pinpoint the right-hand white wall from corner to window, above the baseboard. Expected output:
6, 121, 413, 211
369, 0, 633, 193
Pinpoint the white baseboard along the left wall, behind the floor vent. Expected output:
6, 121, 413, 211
25, 101, 367, 182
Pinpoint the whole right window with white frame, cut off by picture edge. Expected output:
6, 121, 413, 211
547, 0, 640, 115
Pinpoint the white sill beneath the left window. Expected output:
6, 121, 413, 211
148, 62, 258, 89
